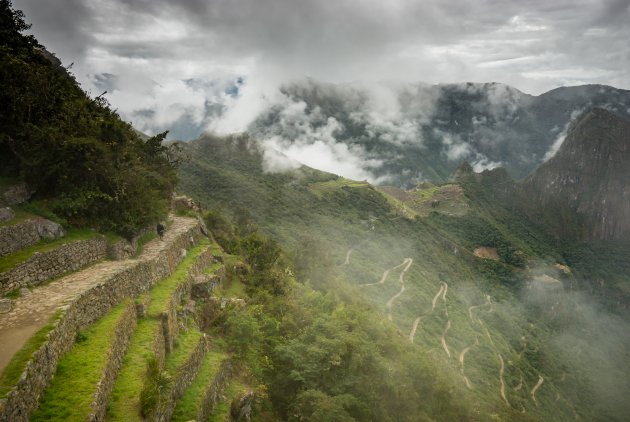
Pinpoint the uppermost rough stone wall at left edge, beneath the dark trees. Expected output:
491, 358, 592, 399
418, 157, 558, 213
0, 218, 65, 257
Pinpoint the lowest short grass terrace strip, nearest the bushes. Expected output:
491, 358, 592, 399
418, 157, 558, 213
171, 351, 227, 422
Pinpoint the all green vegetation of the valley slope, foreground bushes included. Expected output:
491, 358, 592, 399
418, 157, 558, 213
180, 136, 628, 420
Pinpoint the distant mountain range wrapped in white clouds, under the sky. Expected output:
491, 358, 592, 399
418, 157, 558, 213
248, 79, 630, 187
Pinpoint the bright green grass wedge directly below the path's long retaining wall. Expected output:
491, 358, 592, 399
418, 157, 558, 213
31, 300, 129, 421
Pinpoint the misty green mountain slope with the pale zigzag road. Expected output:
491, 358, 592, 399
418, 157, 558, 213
180, 136, 630, 420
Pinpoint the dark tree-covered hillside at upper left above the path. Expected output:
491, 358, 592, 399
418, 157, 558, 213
0, 0, 176, 235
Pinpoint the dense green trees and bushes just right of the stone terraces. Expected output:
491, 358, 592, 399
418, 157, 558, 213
207, 219, 470, 422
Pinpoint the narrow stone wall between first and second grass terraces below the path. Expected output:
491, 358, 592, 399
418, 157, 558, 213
89, 301, 138, 421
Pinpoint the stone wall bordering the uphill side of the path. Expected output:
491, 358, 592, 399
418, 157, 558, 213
0, 236, 107, 294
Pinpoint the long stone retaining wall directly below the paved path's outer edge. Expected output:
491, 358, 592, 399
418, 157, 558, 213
0, 226, 202, 422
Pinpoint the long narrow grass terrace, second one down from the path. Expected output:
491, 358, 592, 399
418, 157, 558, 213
107, 238, 209, 421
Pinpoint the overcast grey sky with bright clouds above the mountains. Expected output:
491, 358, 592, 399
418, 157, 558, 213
14, 0, 630, 136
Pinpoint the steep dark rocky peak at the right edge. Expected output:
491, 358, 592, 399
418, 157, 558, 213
520, 108, 630, 240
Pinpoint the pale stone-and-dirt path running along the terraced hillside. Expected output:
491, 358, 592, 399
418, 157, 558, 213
0, 216, 197, 373
